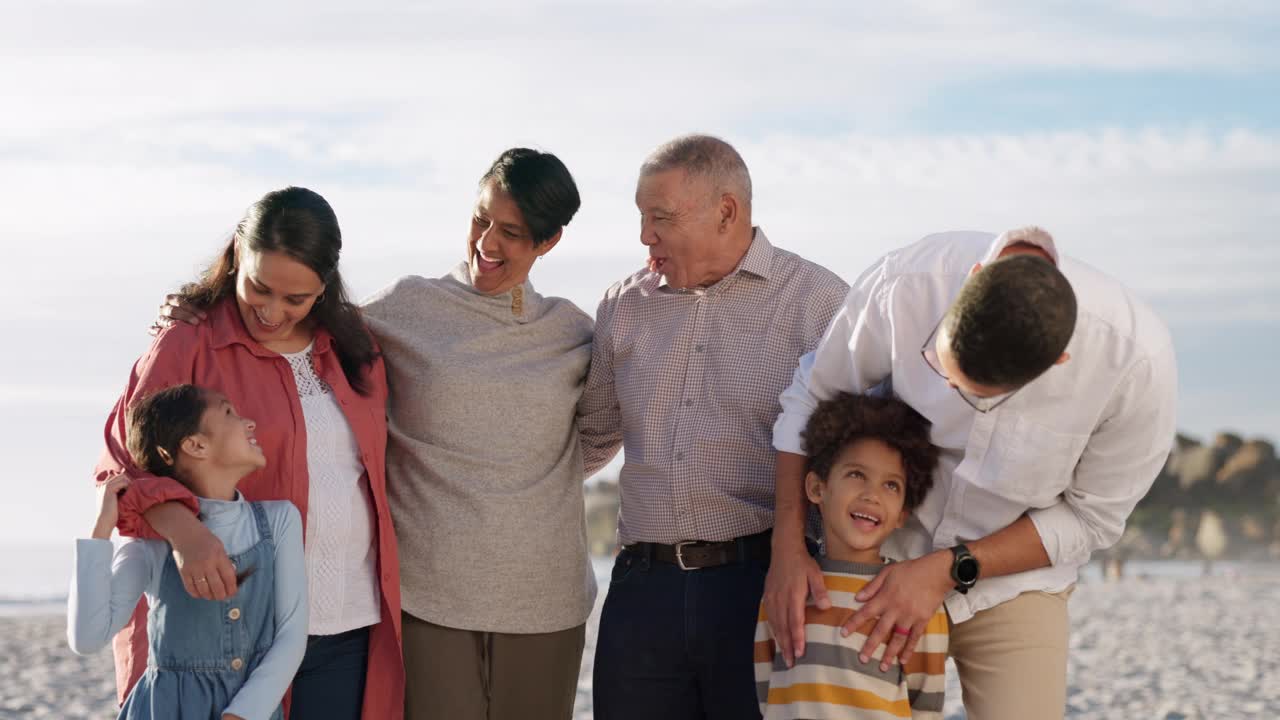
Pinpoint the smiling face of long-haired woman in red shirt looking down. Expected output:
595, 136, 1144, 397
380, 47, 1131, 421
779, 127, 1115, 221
236, 246, 324, 350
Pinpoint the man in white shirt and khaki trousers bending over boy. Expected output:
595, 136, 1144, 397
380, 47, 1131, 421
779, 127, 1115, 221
765, 228, 1178, 720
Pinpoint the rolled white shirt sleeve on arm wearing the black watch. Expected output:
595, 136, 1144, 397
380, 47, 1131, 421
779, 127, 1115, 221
1028, 347, 1178, 565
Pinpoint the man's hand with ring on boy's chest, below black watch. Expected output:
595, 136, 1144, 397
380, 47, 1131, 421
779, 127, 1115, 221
841, 550, 955, 673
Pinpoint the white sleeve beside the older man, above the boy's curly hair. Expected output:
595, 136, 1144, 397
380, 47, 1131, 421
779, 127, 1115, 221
773, 261, 893, 455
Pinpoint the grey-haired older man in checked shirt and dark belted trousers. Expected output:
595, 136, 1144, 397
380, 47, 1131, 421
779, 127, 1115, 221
580, 136, 849, 720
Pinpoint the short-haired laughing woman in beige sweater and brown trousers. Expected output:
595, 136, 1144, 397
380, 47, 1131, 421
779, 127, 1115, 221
161, 147, 620, 720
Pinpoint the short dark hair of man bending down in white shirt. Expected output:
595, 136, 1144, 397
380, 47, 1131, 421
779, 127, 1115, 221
942, 255, 1076, 389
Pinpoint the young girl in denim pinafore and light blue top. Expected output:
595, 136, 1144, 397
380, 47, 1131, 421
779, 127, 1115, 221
67, 384, 307, 720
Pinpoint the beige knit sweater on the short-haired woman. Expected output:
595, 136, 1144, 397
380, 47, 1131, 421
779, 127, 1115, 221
365, 263, 609, 633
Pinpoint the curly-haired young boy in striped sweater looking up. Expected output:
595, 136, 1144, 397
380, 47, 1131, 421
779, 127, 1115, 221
755, 393, 947, 720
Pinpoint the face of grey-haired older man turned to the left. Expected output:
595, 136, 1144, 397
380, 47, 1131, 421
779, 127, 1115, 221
636, 168, 749, 288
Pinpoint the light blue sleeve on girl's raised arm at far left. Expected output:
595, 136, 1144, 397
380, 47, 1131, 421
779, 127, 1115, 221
67, 539, 161, 655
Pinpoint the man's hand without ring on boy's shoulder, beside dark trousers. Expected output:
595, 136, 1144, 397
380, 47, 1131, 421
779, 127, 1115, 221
764, 543, 831, 667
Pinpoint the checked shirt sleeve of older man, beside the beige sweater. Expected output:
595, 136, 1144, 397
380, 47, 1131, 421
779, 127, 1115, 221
577, 285, 622, 477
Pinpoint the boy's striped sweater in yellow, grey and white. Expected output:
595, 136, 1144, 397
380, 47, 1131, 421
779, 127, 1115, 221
755, 557, 948, 720
